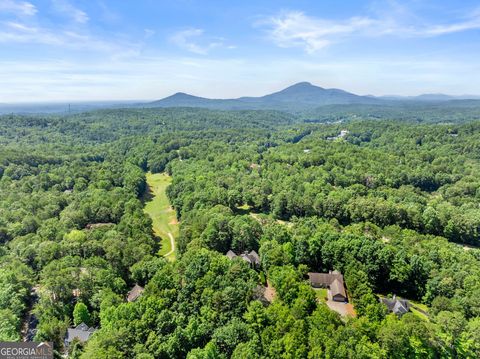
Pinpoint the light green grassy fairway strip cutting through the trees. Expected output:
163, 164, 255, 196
144, 173, 178, 260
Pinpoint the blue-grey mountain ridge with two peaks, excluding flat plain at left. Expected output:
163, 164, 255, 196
149, 82, 480, 111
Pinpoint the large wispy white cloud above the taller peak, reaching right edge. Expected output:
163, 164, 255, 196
257, 7, 480, 53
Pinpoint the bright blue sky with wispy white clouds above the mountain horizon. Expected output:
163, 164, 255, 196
0, 0, 480, 103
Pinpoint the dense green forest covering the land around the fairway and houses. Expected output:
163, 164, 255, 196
0, 107, 480, 359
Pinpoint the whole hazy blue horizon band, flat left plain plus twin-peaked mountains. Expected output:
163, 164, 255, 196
0, 82, 480, 113
